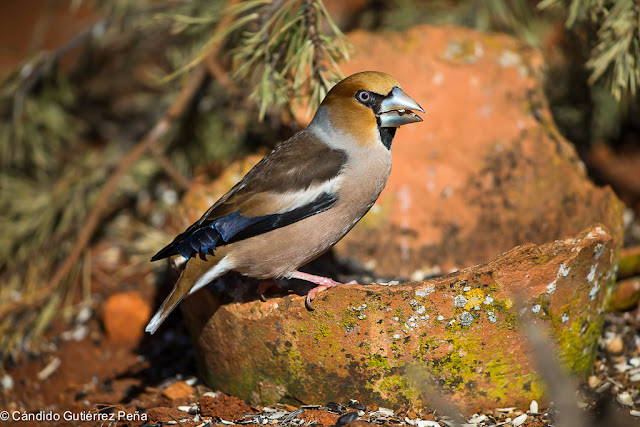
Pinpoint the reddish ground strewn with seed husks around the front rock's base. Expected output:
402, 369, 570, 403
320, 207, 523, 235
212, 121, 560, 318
0, 282, 640, 427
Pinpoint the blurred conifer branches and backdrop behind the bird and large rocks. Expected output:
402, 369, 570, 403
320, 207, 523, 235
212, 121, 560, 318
0, 0, 640, 424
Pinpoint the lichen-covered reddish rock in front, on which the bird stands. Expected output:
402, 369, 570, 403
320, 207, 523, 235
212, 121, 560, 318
183, 226, 617, 413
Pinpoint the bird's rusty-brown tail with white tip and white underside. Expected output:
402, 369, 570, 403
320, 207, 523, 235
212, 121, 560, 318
144, 251, 233, 334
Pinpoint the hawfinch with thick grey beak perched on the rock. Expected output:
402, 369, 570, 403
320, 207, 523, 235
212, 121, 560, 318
145, 71, 424, 334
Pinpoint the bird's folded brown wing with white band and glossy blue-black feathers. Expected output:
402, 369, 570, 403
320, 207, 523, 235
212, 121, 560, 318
151, 131, 347, 261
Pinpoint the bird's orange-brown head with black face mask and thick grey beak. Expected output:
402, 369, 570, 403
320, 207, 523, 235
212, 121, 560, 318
314, 71, 424, 148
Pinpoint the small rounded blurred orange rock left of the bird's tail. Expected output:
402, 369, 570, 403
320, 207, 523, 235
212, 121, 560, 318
103, 291, 151, 344
